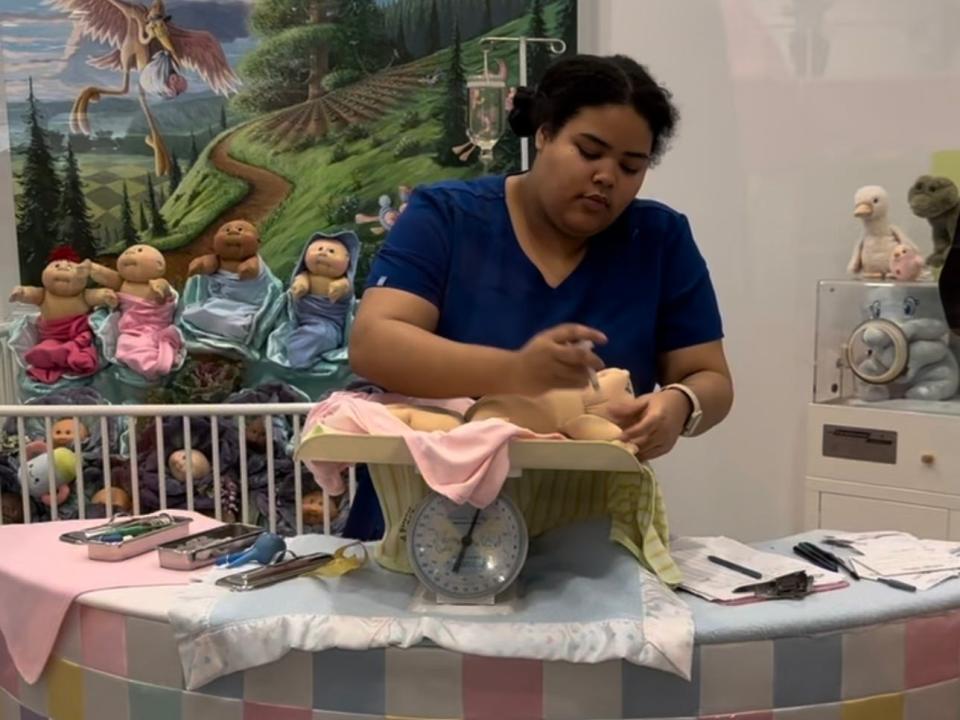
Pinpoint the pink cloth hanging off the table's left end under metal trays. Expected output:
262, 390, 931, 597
0, 510, 221, 684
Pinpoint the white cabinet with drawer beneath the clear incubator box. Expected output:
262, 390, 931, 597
805, 402, 960, 540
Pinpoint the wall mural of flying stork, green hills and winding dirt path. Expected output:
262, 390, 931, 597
0, 0, 577, 289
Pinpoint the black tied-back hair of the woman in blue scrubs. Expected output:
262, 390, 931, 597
509, 55, 680, 162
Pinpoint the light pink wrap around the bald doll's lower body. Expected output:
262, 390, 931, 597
117, 293, 183, 379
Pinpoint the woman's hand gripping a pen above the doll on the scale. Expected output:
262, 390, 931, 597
511, 323, 607, 395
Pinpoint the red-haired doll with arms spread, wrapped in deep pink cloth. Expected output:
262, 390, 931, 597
10, 247, 118, 384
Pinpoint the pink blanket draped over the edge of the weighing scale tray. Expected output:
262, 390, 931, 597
304, 392, 564, 508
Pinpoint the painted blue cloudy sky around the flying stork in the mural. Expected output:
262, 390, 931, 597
0, 0, 255, 102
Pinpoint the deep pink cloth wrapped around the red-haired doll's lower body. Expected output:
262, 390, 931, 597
23, 315, 99, 383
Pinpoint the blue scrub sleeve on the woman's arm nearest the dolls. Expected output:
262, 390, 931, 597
366, 189, 452, 308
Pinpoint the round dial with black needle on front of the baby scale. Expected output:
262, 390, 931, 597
407, 494, 527, 601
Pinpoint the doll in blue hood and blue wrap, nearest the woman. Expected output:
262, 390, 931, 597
287, 237, 353, 368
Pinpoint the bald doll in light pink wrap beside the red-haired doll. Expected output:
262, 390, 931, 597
90, 245, 183, 379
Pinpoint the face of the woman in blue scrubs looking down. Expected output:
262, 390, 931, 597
535, 105, 653, 238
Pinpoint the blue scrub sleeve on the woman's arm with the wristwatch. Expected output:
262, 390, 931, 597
657, 215, 723, 353
